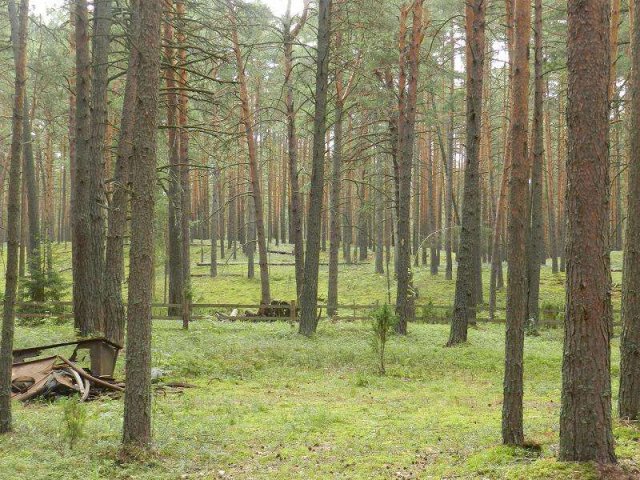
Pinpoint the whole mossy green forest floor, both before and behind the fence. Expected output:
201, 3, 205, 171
0, 248, 640, 480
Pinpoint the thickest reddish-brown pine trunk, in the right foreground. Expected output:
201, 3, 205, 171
560, 0, 616, 463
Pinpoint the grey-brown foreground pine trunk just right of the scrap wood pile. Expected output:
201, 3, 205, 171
122, 1, 162, 447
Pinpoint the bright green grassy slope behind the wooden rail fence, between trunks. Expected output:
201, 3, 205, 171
0, 244, 622, 315
